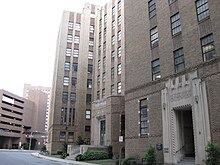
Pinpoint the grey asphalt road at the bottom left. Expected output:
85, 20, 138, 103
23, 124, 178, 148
0, 150, 67, 165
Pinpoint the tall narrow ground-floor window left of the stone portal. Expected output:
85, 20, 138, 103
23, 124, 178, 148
140, 99, 149, 135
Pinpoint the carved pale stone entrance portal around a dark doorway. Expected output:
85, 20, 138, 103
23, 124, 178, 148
161, 72, 210, 165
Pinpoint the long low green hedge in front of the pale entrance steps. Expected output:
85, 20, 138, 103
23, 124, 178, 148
76, 151, 108, 161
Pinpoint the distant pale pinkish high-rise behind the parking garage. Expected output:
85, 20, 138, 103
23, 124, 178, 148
23, 84, 51, 131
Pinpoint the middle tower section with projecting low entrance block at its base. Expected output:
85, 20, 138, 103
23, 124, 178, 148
91, 0, 125, 157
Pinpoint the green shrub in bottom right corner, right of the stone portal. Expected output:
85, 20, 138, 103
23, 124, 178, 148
206, 142, 220, 165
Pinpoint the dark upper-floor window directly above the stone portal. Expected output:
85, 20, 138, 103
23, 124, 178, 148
174, 48, 185, 72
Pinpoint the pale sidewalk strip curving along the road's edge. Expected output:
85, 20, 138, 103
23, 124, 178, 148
31, 153, 97, 165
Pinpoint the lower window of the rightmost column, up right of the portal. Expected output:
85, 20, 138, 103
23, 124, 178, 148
201, 34, 215, 61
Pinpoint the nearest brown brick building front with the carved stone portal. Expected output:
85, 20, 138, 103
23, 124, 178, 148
124, 0, 220, 164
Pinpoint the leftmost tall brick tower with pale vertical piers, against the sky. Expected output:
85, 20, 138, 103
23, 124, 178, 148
48, 3, 99, 153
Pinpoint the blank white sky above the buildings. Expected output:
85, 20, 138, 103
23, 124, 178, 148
0, 0, 109, 96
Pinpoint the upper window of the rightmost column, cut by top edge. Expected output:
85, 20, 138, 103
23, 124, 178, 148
196, 0, 209, 21
